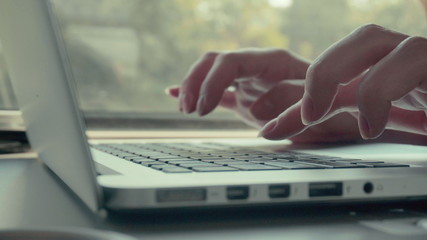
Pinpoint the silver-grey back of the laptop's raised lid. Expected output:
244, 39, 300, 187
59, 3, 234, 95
0, 0, 100, 210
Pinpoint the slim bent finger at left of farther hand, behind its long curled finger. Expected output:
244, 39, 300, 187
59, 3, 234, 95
179, 52, 218, 113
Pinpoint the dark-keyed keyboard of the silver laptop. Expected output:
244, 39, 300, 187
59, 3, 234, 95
92, 143, 409, 173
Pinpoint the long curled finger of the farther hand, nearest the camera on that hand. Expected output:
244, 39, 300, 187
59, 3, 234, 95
197, 50, 307, 115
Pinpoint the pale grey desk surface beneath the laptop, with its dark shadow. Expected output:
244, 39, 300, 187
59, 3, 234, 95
0, 143, 427, 240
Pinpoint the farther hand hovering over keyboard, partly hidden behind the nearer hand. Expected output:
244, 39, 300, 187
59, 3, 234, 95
168, 49, 360, 142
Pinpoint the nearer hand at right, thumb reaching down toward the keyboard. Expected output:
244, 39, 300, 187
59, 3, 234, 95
261, 25, 427, 139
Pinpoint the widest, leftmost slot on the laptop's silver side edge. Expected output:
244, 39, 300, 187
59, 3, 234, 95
156, 188, 206, 203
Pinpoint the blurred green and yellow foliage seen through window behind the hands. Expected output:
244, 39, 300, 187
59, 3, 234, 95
0, 0, 427, 128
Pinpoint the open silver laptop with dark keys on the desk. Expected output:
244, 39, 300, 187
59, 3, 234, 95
0, 0, 427, 211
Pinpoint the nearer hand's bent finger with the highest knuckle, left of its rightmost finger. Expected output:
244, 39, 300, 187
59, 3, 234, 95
302, 25, 408, 124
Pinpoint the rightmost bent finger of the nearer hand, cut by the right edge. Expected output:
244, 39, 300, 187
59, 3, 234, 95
358, 37, 427, 138
